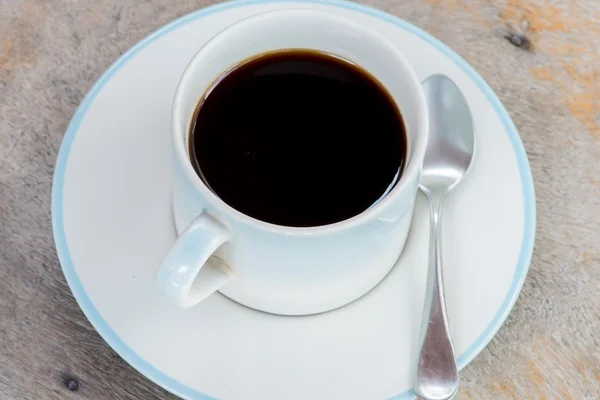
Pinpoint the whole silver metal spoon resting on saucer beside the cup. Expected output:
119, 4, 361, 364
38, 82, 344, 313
413, 75, 475, 400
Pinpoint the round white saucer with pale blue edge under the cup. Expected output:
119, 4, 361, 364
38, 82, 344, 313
52, 0, 535, 400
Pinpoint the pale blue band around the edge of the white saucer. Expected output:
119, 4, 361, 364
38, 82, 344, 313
51, 0, 536, 400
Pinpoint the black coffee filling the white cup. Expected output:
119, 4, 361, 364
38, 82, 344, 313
189, 50, 407, 227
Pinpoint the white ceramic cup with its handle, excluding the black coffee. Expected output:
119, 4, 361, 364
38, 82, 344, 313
156, 9, 428, 315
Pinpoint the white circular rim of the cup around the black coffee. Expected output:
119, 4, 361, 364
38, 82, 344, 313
171, 8, 429, 236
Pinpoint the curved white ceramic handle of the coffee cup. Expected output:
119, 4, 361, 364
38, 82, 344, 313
156, 213, 233, 308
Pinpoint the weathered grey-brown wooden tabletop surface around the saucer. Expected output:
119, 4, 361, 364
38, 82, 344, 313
0, 0, 600, 400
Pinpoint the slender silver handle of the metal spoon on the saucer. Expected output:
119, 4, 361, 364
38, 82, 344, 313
414, 195, 458, 400
